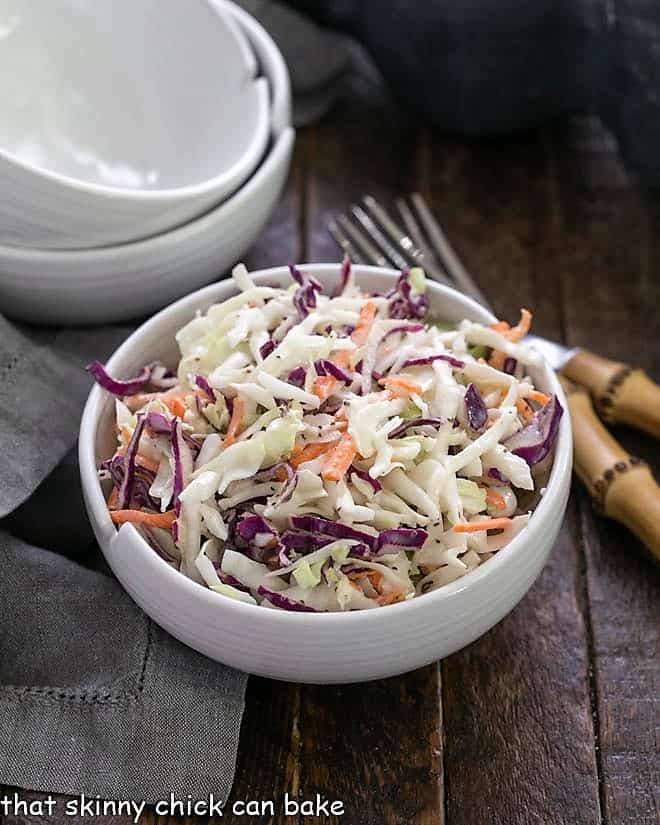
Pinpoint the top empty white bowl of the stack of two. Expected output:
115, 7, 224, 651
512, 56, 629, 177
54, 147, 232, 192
0, 0, 270, 249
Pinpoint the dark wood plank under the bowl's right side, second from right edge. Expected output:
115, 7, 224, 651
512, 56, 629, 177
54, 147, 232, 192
427, 129, 600, 825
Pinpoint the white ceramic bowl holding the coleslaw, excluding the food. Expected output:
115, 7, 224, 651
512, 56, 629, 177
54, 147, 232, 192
79, 264, 572, 683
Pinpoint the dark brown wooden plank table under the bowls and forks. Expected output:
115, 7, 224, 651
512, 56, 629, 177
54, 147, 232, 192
4, 67, 660, 825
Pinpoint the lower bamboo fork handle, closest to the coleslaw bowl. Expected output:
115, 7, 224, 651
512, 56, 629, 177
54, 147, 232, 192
562, 379, 660, 562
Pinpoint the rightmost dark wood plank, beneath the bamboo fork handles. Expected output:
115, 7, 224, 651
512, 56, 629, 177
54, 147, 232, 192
558, 124, 660, 825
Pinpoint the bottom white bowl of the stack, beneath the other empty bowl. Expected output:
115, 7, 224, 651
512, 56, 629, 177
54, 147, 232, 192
0, 4, 294, 324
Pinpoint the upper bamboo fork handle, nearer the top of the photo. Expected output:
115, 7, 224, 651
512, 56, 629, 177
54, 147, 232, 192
562, 350, 660, 438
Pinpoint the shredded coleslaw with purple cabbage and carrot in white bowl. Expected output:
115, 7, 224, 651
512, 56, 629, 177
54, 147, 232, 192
88, 259, 562, 612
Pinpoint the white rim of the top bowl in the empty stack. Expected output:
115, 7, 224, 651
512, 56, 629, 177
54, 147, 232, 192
0, 2, 270, 201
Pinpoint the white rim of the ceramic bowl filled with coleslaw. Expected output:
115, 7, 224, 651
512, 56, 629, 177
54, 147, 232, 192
80, 264, 572, 629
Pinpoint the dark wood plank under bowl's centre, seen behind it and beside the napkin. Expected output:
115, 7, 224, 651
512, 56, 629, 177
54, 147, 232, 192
300, 66, 443, 825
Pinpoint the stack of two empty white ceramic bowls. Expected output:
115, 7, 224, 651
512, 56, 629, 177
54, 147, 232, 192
0, 0, 294, 324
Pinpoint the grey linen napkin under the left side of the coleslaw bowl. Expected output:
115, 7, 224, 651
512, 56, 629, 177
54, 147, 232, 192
0, 316, 247, 803
